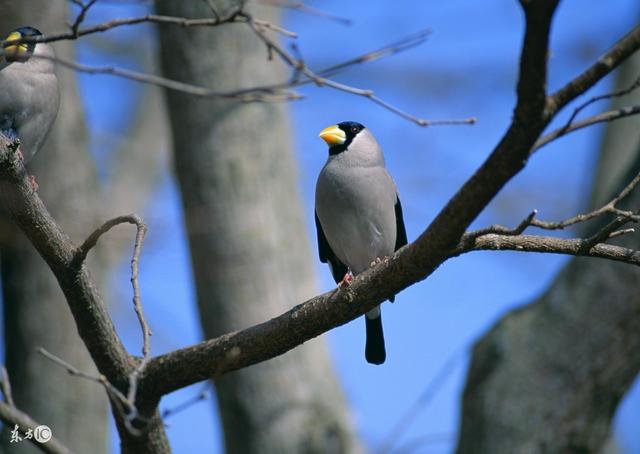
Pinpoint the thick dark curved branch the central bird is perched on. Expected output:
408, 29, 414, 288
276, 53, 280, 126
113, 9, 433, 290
139, 1, 640, 395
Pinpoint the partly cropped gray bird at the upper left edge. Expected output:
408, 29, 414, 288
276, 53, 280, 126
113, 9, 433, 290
0, 27, 60, 162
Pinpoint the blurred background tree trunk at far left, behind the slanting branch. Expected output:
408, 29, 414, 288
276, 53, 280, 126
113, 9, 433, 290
0, 0, 108, 454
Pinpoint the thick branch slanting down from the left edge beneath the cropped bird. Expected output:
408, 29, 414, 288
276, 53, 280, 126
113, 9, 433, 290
0, 134, 168, 453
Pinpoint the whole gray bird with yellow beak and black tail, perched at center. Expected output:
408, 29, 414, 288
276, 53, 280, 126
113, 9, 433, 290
315, 121, 407, 364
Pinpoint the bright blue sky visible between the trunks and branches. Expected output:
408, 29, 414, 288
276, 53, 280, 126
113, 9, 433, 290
5, 0, 640, 453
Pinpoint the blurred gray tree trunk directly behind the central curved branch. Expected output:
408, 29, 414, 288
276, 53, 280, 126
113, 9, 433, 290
156, 0, 359, 453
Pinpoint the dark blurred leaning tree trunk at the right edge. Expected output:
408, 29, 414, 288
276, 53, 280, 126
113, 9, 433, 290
458, 50, 640, 453
